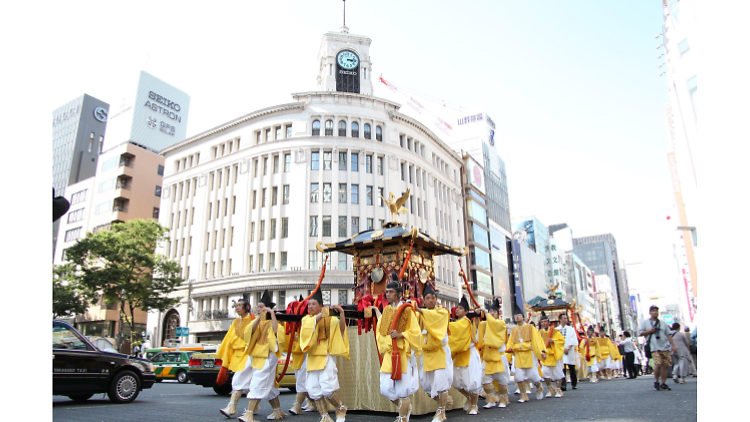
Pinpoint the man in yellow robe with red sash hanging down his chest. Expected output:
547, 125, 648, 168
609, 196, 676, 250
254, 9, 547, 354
370, 281, 422, 422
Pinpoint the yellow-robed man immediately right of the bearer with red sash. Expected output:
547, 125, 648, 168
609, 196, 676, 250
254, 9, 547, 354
417, 284, 453, 422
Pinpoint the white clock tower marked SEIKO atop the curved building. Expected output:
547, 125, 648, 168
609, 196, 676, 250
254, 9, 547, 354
318, 26, 372, 95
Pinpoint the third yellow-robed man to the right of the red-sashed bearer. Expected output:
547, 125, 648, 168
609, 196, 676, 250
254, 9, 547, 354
477, 299, 510, 409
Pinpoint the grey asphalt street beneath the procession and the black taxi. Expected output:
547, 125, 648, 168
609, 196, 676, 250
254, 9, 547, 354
52, 376, 698, 422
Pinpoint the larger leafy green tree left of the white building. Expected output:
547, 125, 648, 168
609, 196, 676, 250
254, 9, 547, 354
66, 220, 183, 344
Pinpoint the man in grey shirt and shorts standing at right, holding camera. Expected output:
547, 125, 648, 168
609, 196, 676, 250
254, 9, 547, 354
640, 305, 677, 391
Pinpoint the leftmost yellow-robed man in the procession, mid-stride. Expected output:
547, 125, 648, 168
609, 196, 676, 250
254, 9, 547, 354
216, 298, 255, 418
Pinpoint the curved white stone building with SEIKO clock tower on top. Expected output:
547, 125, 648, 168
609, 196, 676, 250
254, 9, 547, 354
148, 28, 467, 345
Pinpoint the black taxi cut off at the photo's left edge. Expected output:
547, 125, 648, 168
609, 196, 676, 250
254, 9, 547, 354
52, 320, 156, 403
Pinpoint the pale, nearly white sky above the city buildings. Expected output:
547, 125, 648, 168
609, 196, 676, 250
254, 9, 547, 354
49, 0, 676, 300
